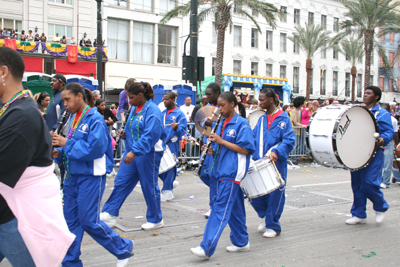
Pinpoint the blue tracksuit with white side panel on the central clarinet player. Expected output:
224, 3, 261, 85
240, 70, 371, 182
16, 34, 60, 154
200, 114, 254, 257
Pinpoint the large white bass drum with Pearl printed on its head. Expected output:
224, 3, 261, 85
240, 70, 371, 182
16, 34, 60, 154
306, 105, 378, 171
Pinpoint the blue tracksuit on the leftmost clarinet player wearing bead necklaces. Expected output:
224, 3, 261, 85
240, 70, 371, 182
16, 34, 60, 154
56, 109, 133, 267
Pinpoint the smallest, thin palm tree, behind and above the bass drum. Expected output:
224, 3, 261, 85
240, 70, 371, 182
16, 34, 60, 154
340, 37, 364, 104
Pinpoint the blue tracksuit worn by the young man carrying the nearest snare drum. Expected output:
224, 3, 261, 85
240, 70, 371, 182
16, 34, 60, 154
251, 112, 295, 233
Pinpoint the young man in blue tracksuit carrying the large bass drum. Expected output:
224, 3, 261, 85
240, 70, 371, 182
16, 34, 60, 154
346, 85, 394, 224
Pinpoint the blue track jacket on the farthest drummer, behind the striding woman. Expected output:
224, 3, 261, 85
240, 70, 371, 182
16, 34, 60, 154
162, 107, 187, 143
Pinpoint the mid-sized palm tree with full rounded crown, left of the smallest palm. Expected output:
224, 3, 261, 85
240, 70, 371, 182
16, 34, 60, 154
288, 23, 332, 101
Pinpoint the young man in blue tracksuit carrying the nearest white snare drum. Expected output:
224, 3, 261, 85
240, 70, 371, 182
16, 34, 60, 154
251, 88, 295, 237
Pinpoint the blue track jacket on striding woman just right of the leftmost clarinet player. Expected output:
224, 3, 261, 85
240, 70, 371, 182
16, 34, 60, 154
125, 99, 165, 156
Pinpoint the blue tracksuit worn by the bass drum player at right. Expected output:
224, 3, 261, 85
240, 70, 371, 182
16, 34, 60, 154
351, 105, 395, 218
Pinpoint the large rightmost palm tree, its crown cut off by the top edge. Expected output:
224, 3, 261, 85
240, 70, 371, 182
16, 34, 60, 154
338, 0, 400, 88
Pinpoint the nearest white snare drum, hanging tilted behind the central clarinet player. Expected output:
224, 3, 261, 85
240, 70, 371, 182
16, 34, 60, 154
240, 159, 285, 199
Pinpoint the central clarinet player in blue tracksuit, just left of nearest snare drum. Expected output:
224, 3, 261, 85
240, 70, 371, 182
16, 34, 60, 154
191, 92, 254, 259
